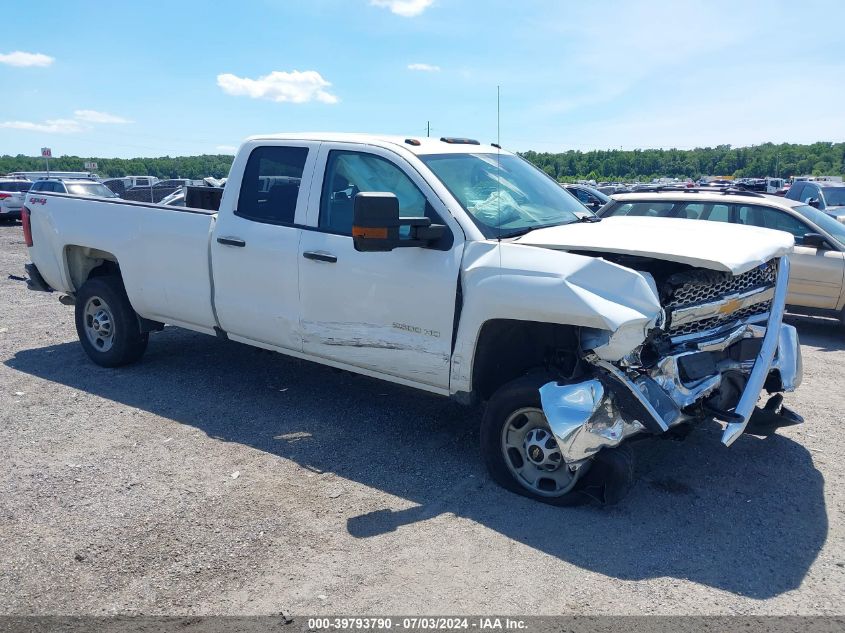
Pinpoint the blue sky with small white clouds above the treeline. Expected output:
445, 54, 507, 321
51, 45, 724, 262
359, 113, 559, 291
0, 0, 845, 157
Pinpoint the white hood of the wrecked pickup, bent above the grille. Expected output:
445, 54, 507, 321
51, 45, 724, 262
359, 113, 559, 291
517, 216, 795, 275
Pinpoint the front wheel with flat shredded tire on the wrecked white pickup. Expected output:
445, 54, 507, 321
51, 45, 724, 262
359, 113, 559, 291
481, 374, 633, 506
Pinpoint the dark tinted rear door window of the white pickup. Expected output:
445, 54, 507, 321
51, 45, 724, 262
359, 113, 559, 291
235, 146, 308, 224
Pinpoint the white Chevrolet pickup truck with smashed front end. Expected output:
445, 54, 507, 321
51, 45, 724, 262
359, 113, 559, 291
23, 134, 801, 505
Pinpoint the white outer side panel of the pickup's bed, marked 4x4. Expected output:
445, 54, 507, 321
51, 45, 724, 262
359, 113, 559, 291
25, 192, 221, 332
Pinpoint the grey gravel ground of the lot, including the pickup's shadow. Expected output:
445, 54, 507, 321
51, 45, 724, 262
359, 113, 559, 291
0, 220, 845, 615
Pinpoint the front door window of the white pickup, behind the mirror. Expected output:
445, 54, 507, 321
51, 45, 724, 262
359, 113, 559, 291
319, 151, 428, 235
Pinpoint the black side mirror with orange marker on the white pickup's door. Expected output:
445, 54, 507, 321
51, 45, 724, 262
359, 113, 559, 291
352, 191, 446, 253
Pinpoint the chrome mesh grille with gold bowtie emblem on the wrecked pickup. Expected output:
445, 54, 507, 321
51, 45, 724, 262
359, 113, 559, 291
666, 262, 777, 337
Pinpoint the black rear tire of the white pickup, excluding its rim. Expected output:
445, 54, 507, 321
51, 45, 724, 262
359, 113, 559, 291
74, 276, 147, 367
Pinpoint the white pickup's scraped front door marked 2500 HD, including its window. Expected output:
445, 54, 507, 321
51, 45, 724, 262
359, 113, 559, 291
299, 143, 463, 389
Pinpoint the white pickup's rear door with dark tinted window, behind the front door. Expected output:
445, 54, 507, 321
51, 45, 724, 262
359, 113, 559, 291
211, 142, 319, 351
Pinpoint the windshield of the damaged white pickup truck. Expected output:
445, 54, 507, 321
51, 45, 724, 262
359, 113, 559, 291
420, 154, 590, 238
